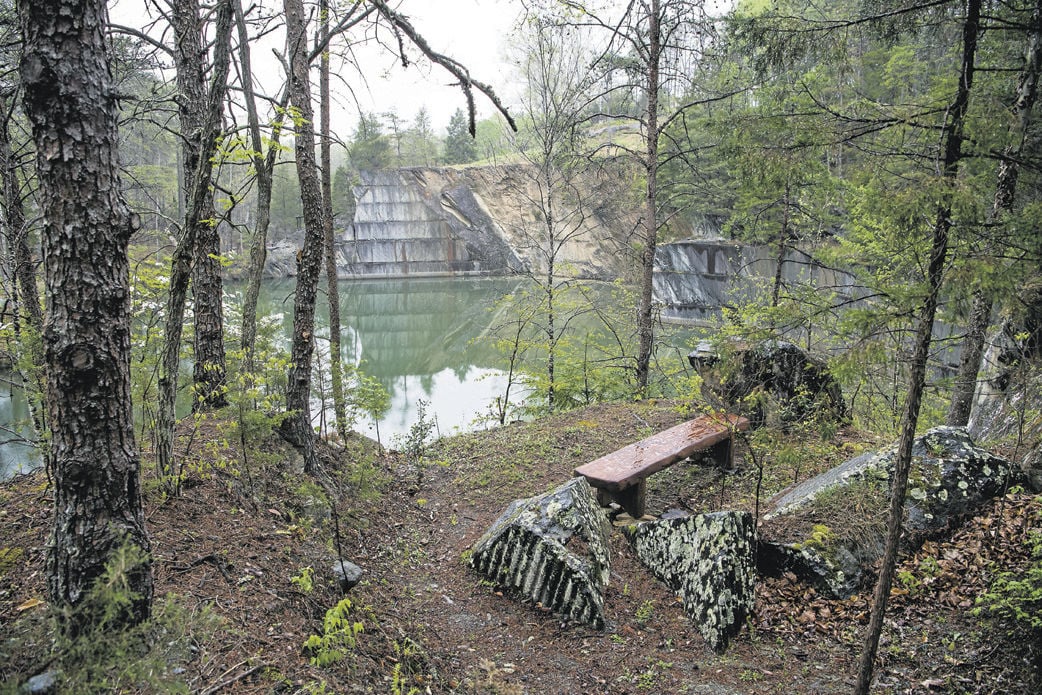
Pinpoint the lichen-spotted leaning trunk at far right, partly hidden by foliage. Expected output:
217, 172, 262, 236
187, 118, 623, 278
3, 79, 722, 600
947, 2, 1042, 427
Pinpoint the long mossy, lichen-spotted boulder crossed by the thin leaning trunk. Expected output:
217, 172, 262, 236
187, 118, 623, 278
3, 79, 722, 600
758, 427, 1022, 597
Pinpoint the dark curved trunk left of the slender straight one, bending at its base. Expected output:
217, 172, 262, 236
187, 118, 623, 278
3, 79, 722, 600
281, 0, 324, 473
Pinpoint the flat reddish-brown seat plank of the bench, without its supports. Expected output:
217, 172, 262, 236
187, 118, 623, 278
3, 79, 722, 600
575, 415, 749, 492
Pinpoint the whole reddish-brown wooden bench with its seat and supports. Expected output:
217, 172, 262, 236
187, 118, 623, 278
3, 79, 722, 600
575, 414, 749, 519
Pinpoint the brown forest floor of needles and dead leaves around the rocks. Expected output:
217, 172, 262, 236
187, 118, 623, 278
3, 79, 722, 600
0, 401, 1042, 695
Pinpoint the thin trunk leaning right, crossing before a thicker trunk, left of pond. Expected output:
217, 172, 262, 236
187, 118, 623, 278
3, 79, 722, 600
155, 0, 232, 479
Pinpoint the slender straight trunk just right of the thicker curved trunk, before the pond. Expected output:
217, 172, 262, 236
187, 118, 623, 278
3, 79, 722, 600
319, 0, 348, 439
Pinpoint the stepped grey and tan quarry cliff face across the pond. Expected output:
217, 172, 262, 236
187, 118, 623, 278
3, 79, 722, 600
337, 165, 636, 279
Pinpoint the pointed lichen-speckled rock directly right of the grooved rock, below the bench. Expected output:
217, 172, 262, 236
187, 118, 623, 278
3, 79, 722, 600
629, 512, 755, 651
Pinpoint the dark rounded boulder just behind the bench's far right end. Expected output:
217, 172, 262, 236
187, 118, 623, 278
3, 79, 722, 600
688, 340, 846, 427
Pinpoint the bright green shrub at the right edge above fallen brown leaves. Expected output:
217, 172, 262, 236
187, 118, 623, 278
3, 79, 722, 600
973, 531, 1042, 644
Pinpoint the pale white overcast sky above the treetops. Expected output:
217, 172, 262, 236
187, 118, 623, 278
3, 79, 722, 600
109, 0, 519, 138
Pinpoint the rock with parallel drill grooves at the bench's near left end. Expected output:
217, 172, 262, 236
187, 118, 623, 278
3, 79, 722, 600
470, 477, 611, 628
